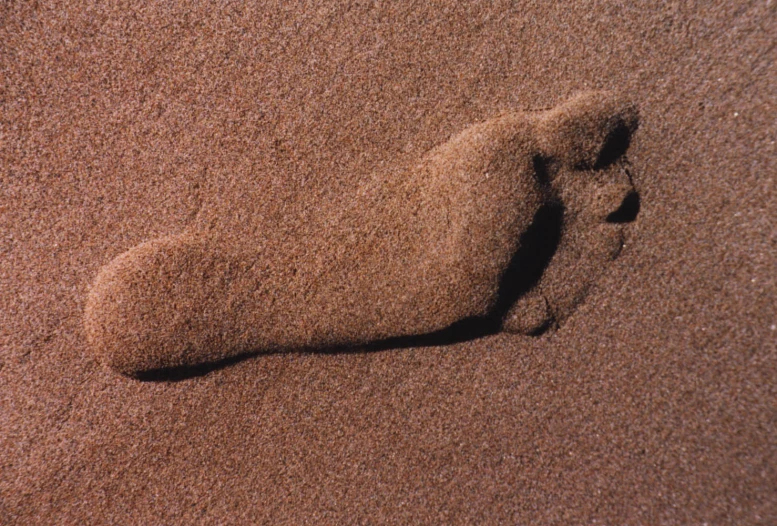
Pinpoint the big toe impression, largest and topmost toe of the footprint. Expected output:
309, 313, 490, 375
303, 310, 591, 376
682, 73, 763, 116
538, 91, 639, 169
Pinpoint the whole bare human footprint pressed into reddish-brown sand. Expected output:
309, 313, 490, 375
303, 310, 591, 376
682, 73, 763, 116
84, 92, 639, 376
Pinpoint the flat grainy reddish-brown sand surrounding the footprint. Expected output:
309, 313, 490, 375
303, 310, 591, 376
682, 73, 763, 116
0, 0, 777, 524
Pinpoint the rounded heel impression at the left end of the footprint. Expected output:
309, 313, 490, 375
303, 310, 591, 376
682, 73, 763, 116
84, 236, 246, 375
